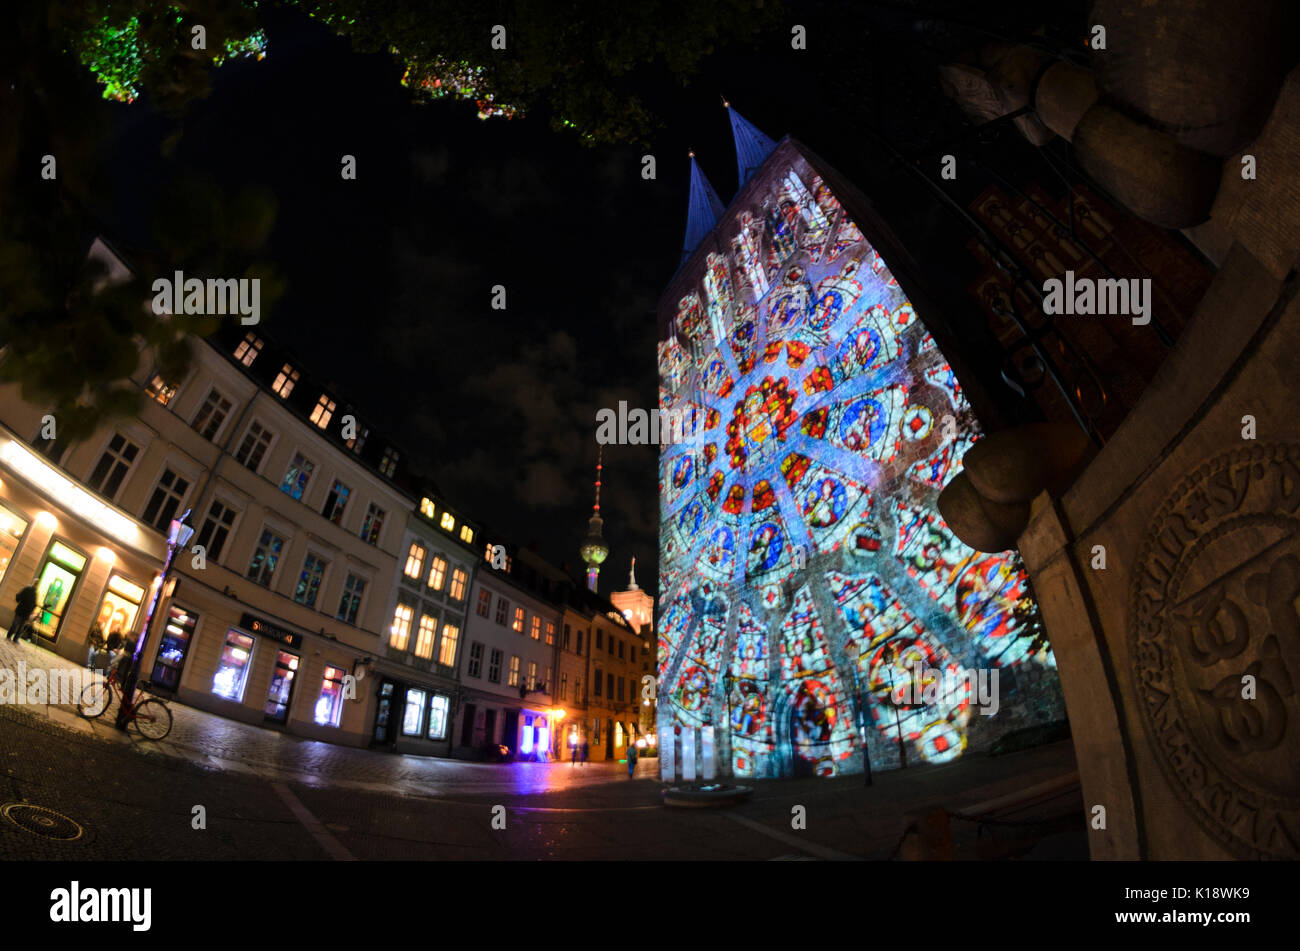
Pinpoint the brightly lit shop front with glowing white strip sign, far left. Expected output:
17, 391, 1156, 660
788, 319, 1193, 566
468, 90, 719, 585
0, 429, 165, 664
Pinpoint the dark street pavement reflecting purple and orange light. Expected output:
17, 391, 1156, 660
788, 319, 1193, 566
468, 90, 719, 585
0, 643, 1087, 860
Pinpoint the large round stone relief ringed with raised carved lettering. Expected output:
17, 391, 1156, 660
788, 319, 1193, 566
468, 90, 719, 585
1128, 444, 1300, 859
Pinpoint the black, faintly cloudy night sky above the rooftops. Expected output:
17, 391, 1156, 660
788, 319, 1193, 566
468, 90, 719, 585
83, 0, 1076, 592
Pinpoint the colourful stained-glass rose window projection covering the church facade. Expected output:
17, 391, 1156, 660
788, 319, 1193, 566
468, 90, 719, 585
658, 149, 1063, 776
